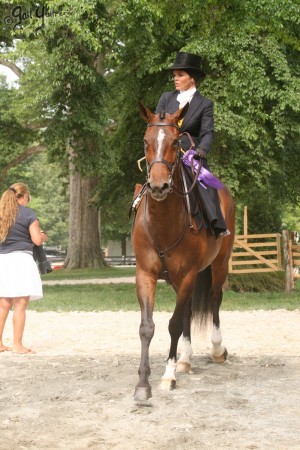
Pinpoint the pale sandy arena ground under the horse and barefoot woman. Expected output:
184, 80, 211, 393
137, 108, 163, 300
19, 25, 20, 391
0, 310, 300, 450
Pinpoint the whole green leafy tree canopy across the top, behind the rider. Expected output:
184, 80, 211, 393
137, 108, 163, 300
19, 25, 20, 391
0, 0, 300, 243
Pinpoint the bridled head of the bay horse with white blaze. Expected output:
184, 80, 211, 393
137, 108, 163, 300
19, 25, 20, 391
138, 102, 188, 201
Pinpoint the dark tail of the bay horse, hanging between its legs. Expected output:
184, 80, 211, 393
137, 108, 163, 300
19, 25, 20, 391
192, 266, 213, 325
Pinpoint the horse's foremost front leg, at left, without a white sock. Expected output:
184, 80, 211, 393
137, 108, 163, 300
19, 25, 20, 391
134, 272, 156, 401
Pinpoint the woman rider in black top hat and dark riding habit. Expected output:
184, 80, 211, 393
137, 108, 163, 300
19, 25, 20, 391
156, 52, 230, 239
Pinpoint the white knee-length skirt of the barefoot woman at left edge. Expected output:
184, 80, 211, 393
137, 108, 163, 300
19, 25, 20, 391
0, 252, 43, 300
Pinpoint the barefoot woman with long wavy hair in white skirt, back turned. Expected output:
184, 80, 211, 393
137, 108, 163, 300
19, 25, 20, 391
0, 183, 48, 354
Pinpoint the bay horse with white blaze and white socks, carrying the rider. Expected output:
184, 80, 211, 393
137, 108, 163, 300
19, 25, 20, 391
132, 102, 235, 401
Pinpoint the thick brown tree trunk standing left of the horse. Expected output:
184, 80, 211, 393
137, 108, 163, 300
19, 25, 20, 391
64, 170, 103, 269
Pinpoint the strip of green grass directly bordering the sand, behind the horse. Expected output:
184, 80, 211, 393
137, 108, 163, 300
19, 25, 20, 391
29, 282, 300, 312
